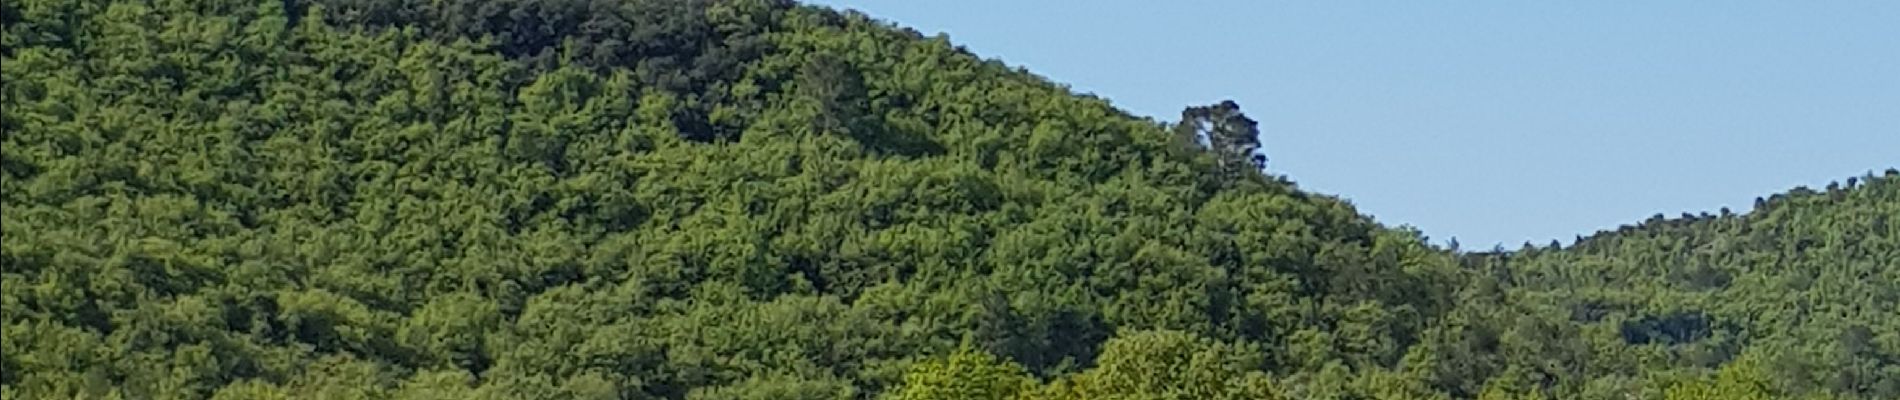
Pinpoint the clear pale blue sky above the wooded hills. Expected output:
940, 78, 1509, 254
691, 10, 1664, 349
817, 0, 1900, 248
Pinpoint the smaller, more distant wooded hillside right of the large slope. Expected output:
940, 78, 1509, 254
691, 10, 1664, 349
1436, 169, 1900, 398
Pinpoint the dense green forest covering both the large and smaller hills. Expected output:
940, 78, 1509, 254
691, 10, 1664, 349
0, 0, 1900, 400
